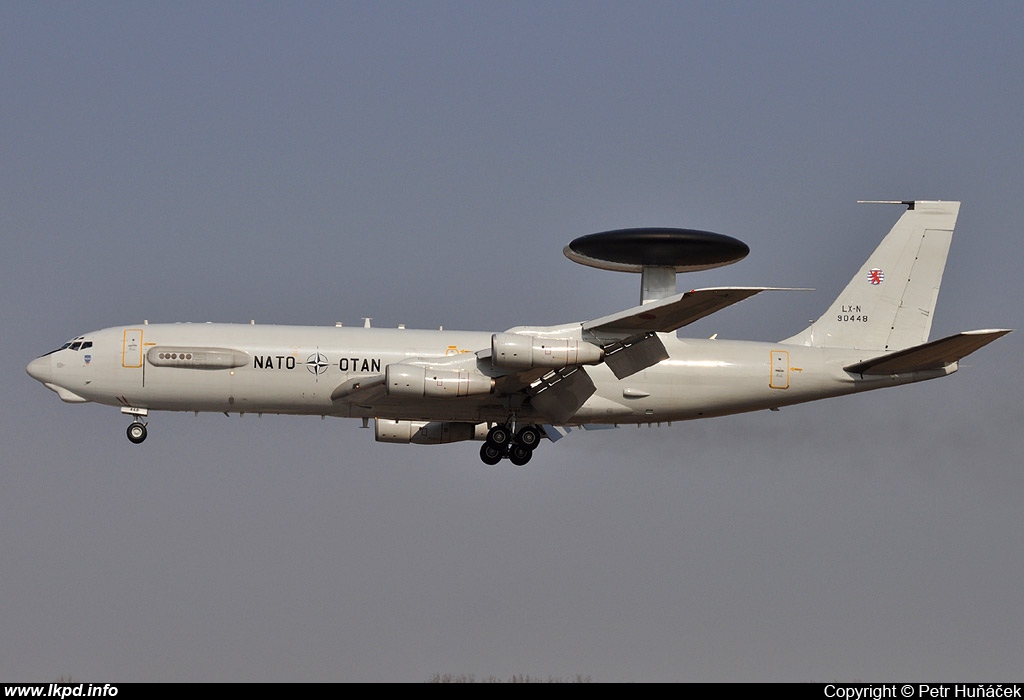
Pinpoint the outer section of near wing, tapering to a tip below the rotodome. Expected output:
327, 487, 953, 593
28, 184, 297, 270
583, 287, 806, 339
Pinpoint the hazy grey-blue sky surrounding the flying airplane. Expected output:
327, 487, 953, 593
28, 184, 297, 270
0, 1, 1024, 683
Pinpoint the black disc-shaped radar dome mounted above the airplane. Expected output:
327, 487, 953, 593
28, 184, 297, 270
562, 228, 751, 272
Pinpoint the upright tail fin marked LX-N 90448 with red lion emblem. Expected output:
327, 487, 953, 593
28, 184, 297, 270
782, 202, 959, 352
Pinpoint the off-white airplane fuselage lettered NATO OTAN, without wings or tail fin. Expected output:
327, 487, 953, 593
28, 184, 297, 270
29, 323, 956, 425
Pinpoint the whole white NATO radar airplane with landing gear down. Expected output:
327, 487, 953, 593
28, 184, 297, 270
27, 201, 1011, 466
